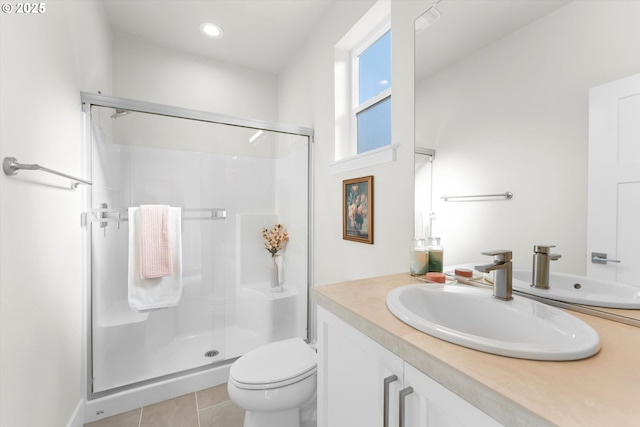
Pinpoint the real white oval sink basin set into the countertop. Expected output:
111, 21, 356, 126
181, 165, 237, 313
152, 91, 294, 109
387, 284, 600, 360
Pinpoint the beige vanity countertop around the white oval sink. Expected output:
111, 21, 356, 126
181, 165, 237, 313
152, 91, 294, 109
311, 273, 640, 427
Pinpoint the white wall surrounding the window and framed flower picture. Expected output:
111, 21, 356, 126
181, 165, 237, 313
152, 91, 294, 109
280, 0, 428, 284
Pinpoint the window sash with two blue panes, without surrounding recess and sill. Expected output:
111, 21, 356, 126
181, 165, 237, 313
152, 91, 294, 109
352, 24, 391, 154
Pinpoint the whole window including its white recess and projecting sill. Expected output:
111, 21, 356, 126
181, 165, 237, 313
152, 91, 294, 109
329, 1, 396, 174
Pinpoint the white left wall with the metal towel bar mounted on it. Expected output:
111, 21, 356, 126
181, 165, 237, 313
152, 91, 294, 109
0, 1, 111, 426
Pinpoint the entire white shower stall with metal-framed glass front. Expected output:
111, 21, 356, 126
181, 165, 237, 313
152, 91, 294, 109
82, 93, 313, 420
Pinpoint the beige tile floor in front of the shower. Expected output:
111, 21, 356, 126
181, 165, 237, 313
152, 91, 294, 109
84, 384, 244, 427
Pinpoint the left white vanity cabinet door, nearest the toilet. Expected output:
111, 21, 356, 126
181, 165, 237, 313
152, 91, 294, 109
318, 307, 403, 427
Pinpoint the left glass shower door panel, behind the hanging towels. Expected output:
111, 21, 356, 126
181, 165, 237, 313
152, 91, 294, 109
89, 107, 227, 393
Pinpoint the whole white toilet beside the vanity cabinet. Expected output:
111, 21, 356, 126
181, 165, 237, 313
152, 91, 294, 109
227, 338, 317, 427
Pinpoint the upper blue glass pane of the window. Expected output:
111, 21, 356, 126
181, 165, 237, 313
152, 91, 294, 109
358, 31, 391, 104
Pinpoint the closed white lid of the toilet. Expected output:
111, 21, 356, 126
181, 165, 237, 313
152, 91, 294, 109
229, 338, 317, 385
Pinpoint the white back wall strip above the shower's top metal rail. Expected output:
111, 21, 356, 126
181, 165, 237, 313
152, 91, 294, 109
113, 33, 278, 121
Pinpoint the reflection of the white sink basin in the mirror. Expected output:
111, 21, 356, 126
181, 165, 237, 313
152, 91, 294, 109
513, 269, 640, 309
